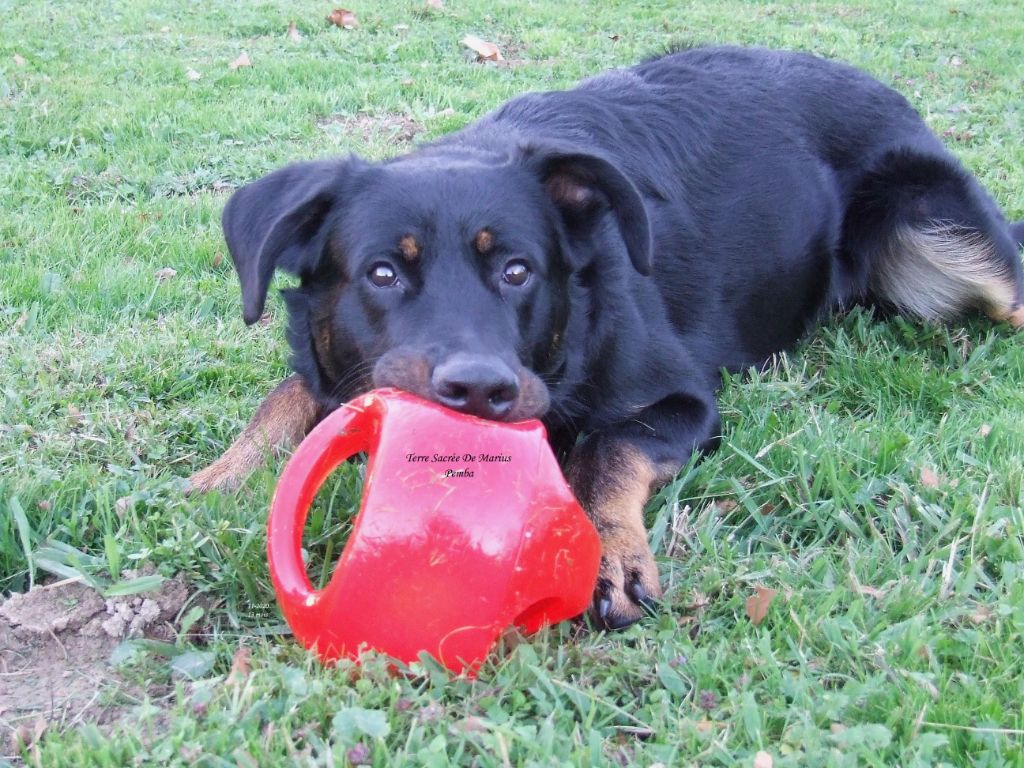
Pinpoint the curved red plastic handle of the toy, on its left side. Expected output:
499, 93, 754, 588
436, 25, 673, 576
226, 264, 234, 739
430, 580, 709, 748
266, 396, 382, 626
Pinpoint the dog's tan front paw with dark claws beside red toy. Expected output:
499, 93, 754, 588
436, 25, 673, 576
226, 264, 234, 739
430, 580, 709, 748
590, 536, 662, 630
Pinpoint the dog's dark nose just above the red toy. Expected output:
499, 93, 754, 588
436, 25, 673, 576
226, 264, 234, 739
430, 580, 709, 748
430, 353, 519, 420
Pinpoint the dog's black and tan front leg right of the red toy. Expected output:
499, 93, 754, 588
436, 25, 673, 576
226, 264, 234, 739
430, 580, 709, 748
568, 397, 719, 629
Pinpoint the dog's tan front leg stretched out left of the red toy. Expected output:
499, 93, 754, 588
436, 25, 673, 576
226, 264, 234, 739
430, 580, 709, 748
188, 376, 321, 493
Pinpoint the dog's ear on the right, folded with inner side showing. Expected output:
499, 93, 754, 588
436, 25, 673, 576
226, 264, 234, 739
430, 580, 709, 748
523, 146, 652, 274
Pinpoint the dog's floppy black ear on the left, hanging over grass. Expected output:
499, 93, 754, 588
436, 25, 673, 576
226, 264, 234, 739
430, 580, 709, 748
221, 160, 357, 325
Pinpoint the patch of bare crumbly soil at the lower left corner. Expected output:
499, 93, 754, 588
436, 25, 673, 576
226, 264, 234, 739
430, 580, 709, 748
0, 579, 188, 754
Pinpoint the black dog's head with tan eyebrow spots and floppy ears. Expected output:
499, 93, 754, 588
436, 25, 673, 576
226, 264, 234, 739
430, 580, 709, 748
223, 145, 651, 421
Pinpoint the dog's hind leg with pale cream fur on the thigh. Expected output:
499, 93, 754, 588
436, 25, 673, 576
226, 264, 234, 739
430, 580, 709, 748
845, 150, 1024, 328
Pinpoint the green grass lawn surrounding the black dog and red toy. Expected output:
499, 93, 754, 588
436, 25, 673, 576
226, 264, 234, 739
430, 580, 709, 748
0, 0, 1024, 766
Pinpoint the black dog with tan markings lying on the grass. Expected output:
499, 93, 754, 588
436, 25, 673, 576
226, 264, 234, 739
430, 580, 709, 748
193, 48, 1024, 627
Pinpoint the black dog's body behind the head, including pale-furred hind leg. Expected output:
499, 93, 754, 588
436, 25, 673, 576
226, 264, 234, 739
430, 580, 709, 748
452, 47, 1024, 370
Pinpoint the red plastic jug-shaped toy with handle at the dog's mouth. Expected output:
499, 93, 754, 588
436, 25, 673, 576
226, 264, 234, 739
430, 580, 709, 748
267, 389, 600, 674
